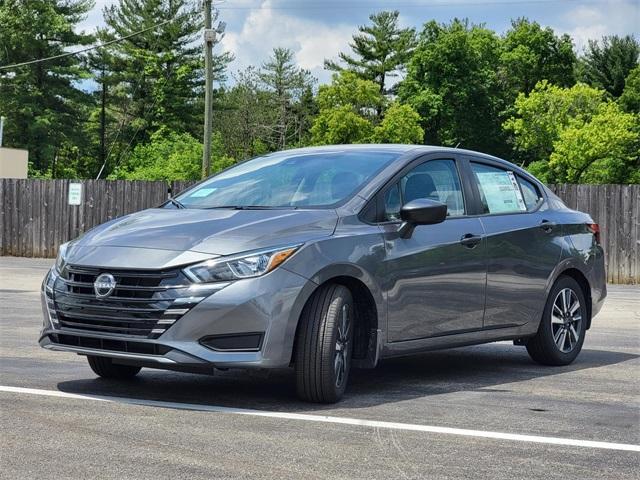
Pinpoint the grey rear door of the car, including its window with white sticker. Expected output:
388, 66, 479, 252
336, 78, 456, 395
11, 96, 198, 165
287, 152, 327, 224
470, 160, 562, 328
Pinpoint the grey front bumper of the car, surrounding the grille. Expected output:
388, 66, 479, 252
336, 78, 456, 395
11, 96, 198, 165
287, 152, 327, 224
39, 267, 315, 370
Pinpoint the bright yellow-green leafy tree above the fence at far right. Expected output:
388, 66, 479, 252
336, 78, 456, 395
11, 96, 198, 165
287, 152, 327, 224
544, 102, 640, 183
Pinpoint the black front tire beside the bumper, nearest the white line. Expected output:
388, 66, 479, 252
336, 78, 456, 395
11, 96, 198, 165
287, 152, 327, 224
295, 284, 355, 403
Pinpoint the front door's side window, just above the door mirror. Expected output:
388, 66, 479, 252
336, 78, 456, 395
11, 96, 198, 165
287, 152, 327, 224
384, 160, 464, 221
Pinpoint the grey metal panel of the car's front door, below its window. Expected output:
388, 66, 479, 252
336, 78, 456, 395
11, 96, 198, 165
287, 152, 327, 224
383, 218, 487, 342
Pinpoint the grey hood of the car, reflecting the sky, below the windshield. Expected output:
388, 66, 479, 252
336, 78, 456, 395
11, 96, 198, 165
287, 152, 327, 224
74, 208, 338, 255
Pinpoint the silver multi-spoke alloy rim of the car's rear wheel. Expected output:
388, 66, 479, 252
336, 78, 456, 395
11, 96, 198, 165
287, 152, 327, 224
551, 288, 582, 353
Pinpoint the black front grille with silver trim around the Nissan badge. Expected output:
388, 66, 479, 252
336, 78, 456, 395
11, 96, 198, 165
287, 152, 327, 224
52, 266, 209, 338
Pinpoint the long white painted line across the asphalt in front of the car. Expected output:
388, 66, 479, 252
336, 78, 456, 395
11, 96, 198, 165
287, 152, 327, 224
0, 385, 640, 452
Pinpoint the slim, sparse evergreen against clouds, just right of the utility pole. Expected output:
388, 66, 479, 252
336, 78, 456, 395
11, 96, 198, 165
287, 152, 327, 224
258, 48, 315, 149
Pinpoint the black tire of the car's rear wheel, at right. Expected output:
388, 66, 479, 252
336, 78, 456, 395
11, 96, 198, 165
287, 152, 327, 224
527, 276, 589, 366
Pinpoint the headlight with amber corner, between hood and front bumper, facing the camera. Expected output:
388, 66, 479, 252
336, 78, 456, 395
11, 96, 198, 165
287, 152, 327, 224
183, 245, 300, 283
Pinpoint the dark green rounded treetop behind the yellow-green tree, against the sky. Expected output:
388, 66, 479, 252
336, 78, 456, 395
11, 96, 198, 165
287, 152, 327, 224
500, 18, 577, 96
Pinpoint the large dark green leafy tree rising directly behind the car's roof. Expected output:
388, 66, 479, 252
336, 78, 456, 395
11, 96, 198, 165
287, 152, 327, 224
398, 19, 507, 155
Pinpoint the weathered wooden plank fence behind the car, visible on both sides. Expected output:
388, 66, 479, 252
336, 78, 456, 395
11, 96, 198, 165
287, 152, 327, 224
0, 179, 640, 283
